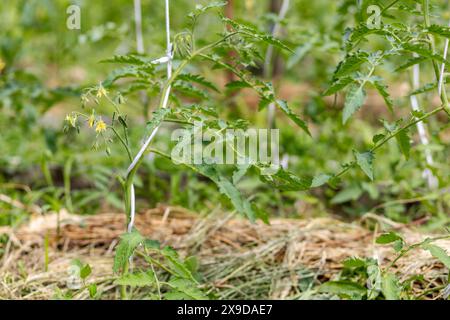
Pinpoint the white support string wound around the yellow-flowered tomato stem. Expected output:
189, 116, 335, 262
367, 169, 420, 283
127, 0, 173, 232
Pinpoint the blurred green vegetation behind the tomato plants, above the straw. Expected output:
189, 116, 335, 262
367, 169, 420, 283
0, 0, 450, 229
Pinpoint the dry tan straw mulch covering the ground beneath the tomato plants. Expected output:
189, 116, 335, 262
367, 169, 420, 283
0, 207, 450, 299
